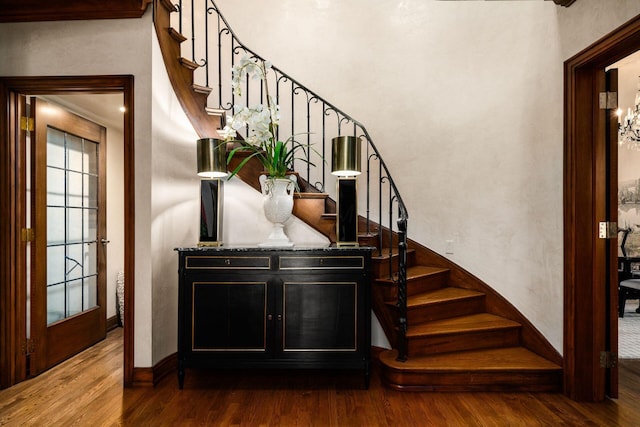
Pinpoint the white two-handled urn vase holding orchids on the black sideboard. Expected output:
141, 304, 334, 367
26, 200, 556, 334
258, 175, 296, 248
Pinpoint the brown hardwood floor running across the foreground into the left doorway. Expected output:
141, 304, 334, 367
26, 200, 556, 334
0, 328, 640, 427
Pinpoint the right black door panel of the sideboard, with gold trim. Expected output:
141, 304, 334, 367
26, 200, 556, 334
282, 282, 358, 351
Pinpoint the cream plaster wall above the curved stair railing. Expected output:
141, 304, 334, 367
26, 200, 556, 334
216, 0, 640, 351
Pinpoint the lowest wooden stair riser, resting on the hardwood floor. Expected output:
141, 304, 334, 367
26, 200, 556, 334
382, 368, 562, 392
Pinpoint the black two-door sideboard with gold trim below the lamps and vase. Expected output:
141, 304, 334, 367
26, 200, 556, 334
176, 247, 372, 388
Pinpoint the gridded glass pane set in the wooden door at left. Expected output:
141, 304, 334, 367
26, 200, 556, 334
47, 127, 99, 324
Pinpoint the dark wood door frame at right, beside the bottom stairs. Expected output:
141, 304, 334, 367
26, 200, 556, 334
563, 15, 640, 401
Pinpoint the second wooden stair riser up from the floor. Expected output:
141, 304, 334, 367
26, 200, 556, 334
408, 328, 520, 357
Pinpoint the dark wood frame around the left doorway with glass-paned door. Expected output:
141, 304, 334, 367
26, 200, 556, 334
0, 75, 135, 388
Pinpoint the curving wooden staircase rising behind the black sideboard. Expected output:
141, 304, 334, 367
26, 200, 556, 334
154, 0, 562, 391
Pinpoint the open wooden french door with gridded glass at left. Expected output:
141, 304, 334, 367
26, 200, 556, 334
27, 97, 107, 375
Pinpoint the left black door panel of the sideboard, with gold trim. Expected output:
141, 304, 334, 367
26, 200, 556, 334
192, 282, 267, 351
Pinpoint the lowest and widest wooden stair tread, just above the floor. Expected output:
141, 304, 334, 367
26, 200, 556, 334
380, 347, 562, 373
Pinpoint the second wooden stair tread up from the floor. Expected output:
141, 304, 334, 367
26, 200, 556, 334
407, 313, 520, 338
